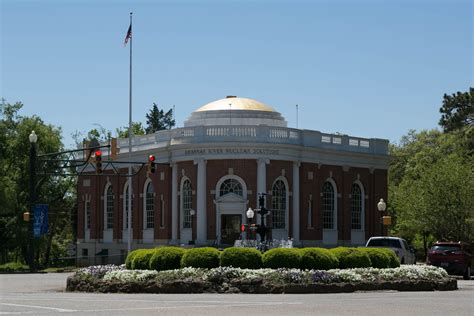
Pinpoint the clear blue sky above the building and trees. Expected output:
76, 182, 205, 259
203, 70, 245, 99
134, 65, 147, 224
0, 0, 474, 147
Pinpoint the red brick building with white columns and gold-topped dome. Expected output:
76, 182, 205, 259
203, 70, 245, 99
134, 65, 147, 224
77, 97, 388, 263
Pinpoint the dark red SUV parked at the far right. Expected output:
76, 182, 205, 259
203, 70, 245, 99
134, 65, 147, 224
426, 241, 474, 280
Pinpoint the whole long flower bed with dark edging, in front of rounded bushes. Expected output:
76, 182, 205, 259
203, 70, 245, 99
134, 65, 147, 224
67, 265, 457, 293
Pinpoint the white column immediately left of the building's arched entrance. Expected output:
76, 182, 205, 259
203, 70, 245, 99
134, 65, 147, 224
194, 159, 207, 244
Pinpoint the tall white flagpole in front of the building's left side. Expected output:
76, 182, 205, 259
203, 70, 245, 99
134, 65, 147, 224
127, 12, 133, 253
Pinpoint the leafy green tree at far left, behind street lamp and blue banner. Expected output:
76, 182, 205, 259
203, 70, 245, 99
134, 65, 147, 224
0, 102, 75, 264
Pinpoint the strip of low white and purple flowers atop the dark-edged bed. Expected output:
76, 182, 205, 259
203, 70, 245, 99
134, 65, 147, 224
76, 265, 448, 285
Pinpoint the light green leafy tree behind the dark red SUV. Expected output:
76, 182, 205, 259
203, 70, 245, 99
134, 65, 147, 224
389, 130, 474, 250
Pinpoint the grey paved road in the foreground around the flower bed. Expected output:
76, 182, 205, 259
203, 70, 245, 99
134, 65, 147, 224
0, 273, 474, 316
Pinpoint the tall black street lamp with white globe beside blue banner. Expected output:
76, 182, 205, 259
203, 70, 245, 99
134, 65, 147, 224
28, 131, 38, 271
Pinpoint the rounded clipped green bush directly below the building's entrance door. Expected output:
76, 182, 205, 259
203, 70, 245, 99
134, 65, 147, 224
220, 247, 262, 269
